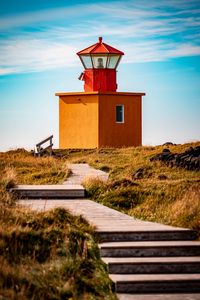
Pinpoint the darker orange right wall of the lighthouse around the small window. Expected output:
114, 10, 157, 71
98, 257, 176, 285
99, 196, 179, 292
99, 93, 142, 148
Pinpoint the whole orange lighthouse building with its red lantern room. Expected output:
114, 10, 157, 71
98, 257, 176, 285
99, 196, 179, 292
56, 37, 145, 149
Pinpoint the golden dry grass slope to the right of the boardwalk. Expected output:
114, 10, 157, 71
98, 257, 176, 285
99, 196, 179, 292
78, 142, 200, 232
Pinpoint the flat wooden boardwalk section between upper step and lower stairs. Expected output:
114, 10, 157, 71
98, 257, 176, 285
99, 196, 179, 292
20, 199, 197, 240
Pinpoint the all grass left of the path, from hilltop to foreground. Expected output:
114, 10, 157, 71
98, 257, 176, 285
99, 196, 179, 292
0, 150, 116, 300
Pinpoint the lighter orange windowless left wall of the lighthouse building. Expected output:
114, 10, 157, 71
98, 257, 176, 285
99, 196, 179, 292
59, 94, 98, 149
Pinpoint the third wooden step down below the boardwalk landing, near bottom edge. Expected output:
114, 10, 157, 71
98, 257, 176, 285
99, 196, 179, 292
109, 274, 200, 294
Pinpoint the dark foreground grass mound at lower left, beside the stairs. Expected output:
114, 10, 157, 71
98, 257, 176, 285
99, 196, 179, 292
0, 203, 116, 300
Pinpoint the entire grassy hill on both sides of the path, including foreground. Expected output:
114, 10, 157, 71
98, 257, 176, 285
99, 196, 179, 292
0, 142, 200, 300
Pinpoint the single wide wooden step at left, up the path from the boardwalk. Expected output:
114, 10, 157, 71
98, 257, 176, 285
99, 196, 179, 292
11, 185, 85, 199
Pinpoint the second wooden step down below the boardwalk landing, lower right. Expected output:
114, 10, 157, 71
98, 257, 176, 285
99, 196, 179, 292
102, 256, 200, 274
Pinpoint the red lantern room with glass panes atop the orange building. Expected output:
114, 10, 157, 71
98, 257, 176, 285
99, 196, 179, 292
77, 37, 124, 92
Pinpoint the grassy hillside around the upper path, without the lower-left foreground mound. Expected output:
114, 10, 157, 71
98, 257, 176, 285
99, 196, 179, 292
0, 142, 200, 229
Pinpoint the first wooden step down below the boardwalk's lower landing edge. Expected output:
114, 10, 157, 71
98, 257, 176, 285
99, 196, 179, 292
99, 241, 200, 257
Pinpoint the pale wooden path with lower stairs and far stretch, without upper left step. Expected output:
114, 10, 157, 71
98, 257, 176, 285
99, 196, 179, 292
17, 164, 200, 300
